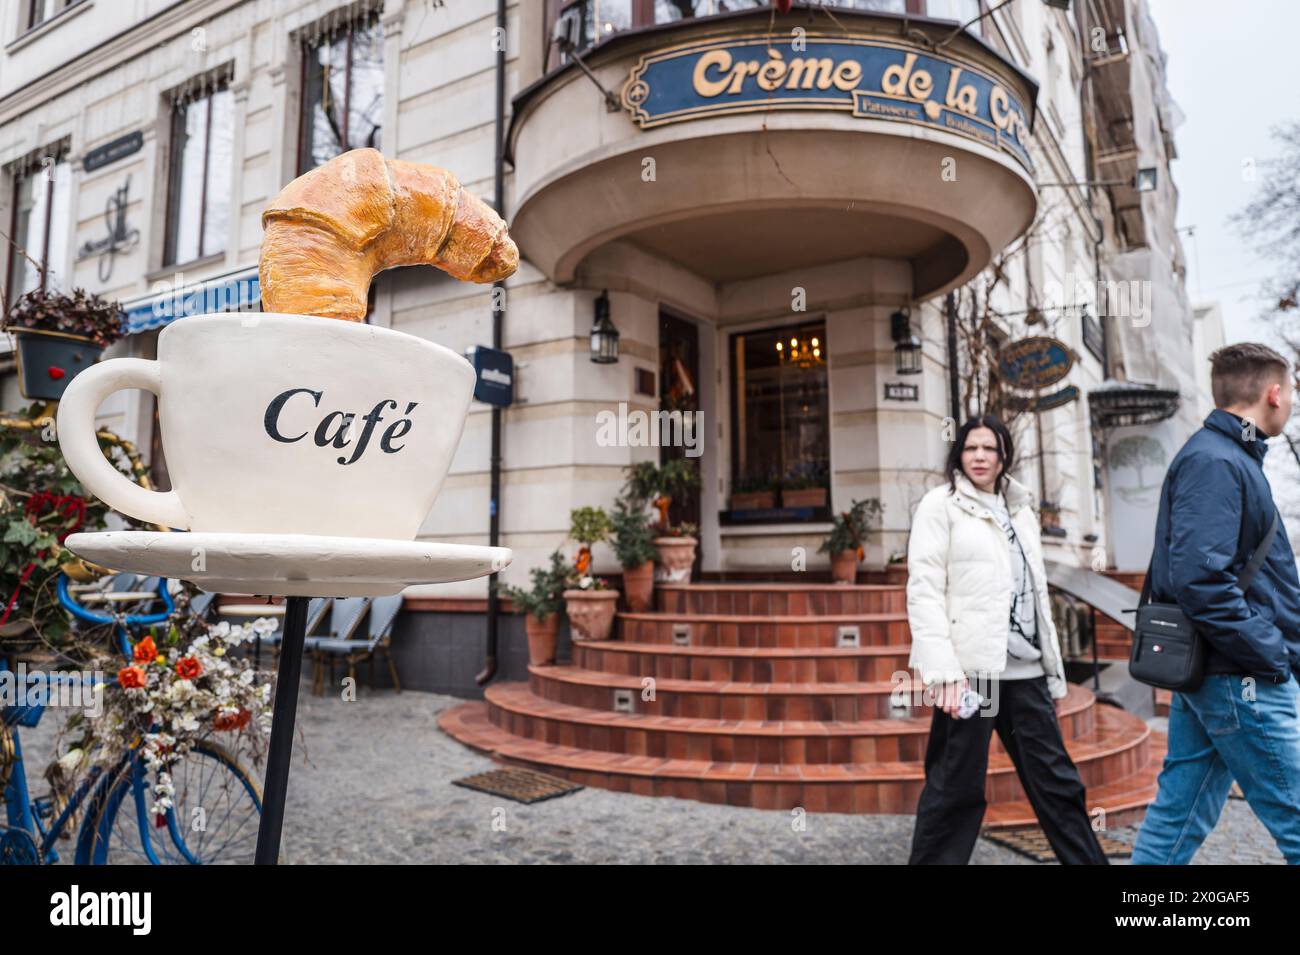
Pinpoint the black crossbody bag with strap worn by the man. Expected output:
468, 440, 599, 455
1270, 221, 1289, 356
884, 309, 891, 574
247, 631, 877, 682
1126, 508, 1278, 693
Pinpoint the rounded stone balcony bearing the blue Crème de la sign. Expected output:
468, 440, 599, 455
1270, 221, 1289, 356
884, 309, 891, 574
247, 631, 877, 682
507, 3, 1037, 300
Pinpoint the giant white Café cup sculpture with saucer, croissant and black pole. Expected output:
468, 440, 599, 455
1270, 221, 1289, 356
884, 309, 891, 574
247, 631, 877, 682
57, 149, 519, 863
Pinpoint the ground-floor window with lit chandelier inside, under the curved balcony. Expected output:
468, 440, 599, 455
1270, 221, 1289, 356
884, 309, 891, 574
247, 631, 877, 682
731, 321, 831, 504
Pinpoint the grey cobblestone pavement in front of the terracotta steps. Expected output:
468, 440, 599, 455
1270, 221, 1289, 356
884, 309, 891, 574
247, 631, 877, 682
22, 683, 1282, 865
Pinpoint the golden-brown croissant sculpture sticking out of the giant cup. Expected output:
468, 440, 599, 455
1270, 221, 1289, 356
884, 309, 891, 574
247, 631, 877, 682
257, 149, 519, 322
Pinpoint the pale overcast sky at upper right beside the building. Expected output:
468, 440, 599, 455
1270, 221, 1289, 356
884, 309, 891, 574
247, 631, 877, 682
1148, 0, 1300, 342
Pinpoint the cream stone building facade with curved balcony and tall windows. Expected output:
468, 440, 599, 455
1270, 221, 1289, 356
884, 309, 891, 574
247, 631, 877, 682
0, 0, 1199, 686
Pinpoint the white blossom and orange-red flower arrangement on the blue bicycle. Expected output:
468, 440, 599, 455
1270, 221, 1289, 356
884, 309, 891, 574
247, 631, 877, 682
47, 597, 278, 816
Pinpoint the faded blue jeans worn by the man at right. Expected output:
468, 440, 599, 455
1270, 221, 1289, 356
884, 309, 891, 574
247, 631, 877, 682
1132, 674, 1300, 865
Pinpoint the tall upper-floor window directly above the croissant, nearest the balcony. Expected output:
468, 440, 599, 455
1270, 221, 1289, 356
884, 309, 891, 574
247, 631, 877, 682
298, 9, 384, 173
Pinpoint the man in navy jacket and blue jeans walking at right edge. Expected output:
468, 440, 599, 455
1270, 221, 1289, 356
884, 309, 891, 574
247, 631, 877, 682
1132, 343, 1300, 865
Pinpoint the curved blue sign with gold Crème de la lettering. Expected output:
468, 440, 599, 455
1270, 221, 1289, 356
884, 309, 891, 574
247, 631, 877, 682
623, 32, 1034, 172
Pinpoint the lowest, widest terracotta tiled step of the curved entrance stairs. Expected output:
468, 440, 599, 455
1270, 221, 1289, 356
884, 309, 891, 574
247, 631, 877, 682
438, 702, 1170, 825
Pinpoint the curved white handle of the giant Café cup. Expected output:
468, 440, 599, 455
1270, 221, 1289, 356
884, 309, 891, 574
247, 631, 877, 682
56, 359, 190, 530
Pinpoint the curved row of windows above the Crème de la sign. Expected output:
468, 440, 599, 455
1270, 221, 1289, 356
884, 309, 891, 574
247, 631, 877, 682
546, 0, 988, 70
